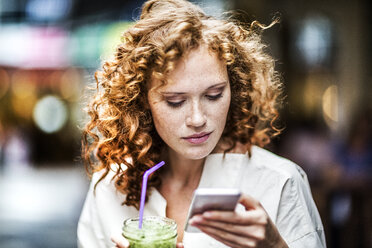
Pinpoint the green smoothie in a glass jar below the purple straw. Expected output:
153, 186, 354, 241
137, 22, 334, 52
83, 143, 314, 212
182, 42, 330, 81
123, 216, 177, 248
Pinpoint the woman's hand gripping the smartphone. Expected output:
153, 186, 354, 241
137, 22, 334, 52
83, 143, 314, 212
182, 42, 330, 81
189, 195, 288, 248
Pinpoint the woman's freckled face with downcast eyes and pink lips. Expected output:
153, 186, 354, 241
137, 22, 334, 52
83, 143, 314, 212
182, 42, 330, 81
148, 46, 231, 159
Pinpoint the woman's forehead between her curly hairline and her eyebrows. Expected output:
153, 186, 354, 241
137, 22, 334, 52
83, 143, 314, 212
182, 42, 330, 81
150, 46, 228, 92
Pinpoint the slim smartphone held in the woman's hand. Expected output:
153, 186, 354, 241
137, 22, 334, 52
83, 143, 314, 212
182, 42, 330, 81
185, 188, 241, 232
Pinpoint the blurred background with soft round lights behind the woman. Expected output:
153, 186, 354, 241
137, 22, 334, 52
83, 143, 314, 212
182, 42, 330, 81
0, 0, 372, 248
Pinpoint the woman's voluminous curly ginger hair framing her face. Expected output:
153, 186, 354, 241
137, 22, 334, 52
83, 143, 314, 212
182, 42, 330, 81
82, 0, 281, 208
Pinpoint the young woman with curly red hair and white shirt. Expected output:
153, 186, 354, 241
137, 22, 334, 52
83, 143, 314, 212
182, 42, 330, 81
78, 0, 325, 248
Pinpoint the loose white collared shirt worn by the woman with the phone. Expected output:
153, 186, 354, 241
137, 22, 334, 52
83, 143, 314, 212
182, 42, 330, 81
78, 147, 326, 248
